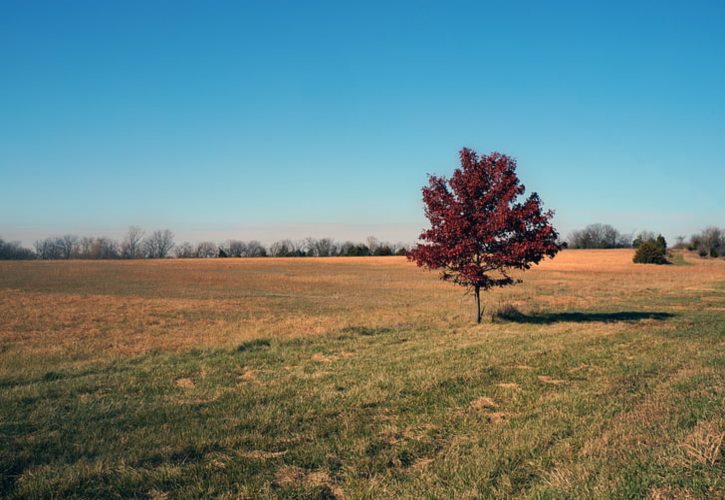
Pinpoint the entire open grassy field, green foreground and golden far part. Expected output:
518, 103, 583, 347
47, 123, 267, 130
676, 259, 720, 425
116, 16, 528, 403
0, 250, 725, 498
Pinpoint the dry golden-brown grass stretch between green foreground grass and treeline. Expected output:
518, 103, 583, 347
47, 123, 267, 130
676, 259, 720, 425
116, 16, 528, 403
0, 250, 725, 364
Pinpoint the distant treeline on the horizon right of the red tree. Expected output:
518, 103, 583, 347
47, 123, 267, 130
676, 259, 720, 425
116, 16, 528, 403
566, 224, 725, 257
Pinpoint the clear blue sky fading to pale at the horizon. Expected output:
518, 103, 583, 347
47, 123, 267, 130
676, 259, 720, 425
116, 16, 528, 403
0, 0, 725, 244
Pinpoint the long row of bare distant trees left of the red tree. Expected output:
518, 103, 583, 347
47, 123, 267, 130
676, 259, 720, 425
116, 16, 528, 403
0, 226, 407, 260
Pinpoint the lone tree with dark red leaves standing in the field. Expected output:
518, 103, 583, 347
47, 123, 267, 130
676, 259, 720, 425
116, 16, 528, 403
408, 148, 560, 323
